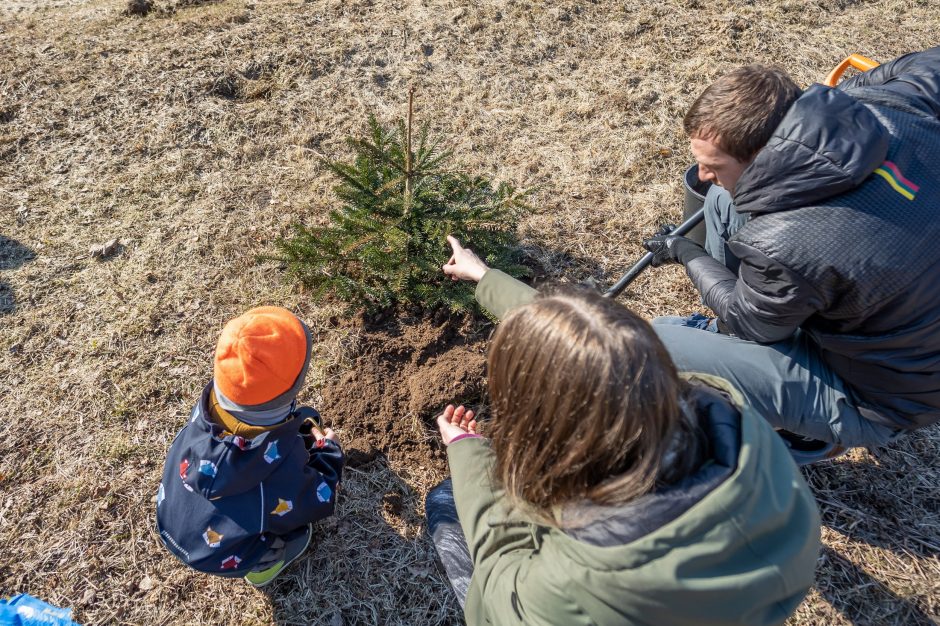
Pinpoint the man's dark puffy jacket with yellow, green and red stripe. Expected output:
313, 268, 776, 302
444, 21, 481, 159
686, 48, 940, 429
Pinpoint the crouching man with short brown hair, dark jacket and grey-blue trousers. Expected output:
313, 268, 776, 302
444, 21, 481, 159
445, 48, 940, 460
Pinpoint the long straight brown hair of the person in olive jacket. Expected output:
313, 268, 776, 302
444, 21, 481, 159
487, 288, 695, 520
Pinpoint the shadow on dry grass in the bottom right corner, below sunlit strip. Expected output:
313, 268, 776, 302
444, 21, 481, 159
816, 546, 936, 626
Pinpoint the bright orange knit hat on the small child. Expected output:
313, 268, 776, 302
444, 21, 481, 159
215, 306, 312, 410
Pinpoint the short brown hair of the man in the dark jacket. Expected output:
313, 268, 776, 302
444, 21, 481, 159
682, 65, 803, 162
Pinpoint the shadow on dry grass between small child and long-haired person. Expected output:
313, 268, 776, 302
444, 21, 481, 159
265, 459, 460, 626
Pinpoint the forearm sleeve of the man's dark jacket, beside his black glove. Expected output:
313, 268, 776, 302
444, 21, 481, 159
686, 241, 823, 343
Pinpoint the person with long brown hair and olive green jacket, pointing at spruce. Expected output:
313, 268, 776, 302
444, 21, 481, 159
426, 258, 820, 626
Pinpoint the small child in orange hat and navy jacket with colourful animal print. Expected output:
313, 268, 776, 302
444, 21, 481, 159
157, 307, 344, 587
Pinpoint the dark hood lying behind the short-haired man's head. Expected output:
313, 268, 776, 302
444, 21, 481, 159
734, 85, 890, 213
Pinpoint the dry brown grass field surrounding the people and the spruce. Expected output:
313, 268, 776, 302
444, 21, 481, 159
0, 0, 940, 626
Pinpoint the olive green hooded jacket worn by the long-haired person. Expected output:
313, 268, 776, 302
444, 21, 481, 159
447, 270, 820, 626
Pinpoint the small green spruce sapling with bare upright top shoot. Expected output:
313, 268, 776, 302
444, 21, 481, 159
276, 93, 529, 311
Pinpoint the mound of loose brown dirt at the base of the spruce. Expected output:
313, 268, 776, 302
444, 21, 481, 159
322, 320, 486, 467
